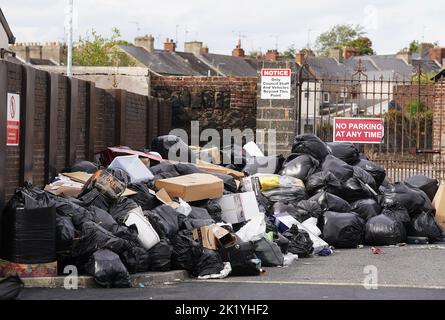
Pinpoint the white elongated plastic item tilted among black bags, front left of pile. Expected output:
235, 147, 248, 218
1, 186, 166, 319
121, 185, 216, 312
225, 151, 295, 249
125, 207, 161, 250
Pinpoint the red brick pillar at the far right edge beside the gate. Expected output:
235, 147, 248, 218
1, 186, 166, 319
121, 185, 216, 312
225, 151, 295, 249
433, 80, 445, 155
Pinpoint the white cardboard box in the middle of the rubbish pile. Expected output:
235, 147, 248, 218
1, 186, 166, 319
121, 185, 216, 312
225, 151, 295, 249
218, 192, 261, 223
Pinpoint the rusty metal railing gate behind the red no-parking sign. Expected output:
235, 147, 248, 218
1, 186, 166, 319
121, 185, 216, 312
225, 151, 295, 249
296, 60, 445, 181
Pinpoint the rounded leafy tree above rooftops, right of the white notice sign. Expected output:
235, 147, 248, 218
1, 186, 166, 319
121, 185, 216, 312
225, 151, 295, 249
316, 24, 366, 56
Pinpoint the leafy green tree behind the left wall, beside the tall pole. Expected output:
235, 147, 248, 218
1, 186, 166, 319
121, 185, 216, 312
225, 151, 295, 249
73, 28, 135, 66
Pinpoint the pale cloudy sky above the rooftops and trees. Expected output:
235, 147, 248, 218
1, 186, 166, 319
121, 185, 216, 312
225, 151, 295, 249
0, 0, 445, 54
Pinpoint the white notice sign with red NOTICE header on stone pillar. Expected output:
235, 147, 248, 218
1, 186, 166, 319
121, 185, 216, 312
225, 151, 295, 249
261, 69, 292, 100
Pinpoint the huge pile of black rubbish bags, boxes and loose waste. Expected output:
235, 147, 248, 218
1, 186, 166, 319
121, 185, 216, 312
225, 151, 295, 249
2, 135, 444, 287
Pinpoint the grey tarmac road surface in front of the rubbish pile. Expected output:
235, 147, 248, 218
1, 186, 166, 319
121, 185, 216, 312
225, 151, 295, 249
15, 244, 445, 300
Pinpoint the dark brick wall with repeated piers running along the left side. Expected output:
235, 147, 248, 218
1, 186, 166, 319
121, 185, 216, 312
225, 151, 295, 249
0, 61, 172, 205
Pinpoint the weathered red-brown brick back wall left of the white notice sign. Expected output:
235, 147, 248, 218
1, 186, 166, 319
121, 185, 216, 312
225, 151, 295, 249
151, 76, 257, 139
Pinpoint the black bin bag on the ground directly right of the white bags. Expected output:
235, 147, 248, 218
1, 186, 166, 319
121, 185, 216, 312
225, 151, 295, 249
323, 212, 365, 248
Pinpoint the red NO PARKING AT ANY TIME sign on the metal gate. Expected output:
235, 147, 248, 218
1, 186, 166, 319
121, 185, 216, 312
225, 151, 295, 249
334, 118, 385, 143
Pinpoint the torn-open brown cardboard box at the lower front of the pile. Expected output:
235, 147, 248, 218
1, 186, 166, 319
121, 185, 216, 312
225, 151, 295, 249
193, 224, 236, 250
